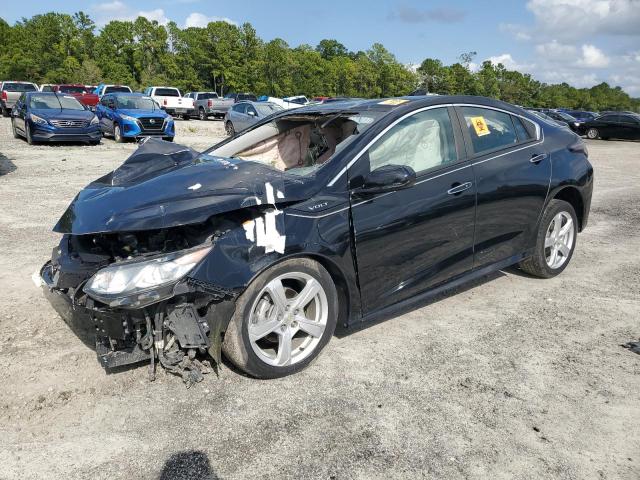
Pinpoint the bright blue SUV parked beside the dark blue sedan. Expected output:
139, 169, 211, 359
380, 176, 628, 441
96, 93, 176, 143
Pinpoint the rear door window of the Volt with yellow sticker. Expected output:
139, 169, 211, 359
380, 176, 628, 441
462, 107, 518, 153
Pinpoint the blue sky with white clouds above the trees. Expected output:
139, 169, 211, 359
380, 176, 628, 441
0, 0, 640, 97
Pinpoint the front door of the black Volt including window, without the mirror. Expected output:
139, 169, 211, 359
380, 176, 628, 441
349, 107, 475, 315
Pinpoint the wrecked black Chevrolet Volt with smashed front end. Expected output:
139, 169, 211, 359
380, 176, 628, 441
41, 96, 593, 384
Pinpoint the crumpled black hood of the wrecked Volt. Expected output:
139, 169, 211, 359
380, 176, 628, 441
53, 138, 307, 235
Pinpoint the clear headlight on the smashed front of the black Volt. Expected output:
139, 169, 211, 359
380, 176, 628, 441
84, 247, 211, 306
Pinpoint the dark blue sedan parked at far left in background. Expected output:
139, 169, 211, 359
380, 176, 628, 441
11, 92, 102, 145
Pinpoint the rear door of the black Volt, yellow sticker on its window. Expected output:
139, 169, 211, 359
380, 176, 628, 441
456, 105, 551, 268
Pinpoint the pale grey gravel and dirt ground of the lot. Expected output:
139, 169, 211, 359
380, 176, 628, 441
0, 119, 640, 480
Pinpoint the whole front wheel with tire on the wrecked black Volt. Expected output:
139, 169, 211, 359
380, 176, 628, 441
222, 258, 338, 379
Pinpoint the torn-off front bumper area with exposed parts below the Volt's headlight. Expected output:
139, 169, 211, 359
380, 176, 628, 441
40, 244, 235, 387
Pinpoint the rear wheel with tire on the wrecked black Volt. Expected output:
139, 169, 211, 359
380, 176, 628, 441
519, 200, 578, 278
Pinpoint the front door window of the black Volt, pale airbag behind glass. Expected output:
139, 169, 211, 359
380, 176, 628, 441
367, 108, 458, 174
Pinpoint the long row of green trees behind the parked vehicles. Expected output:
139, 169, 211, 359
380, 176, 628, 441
0, 12, 640, 110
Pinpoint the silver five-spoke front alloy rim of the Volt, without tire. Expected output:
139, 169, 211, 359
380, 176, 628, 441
247, 272, 329, 367
